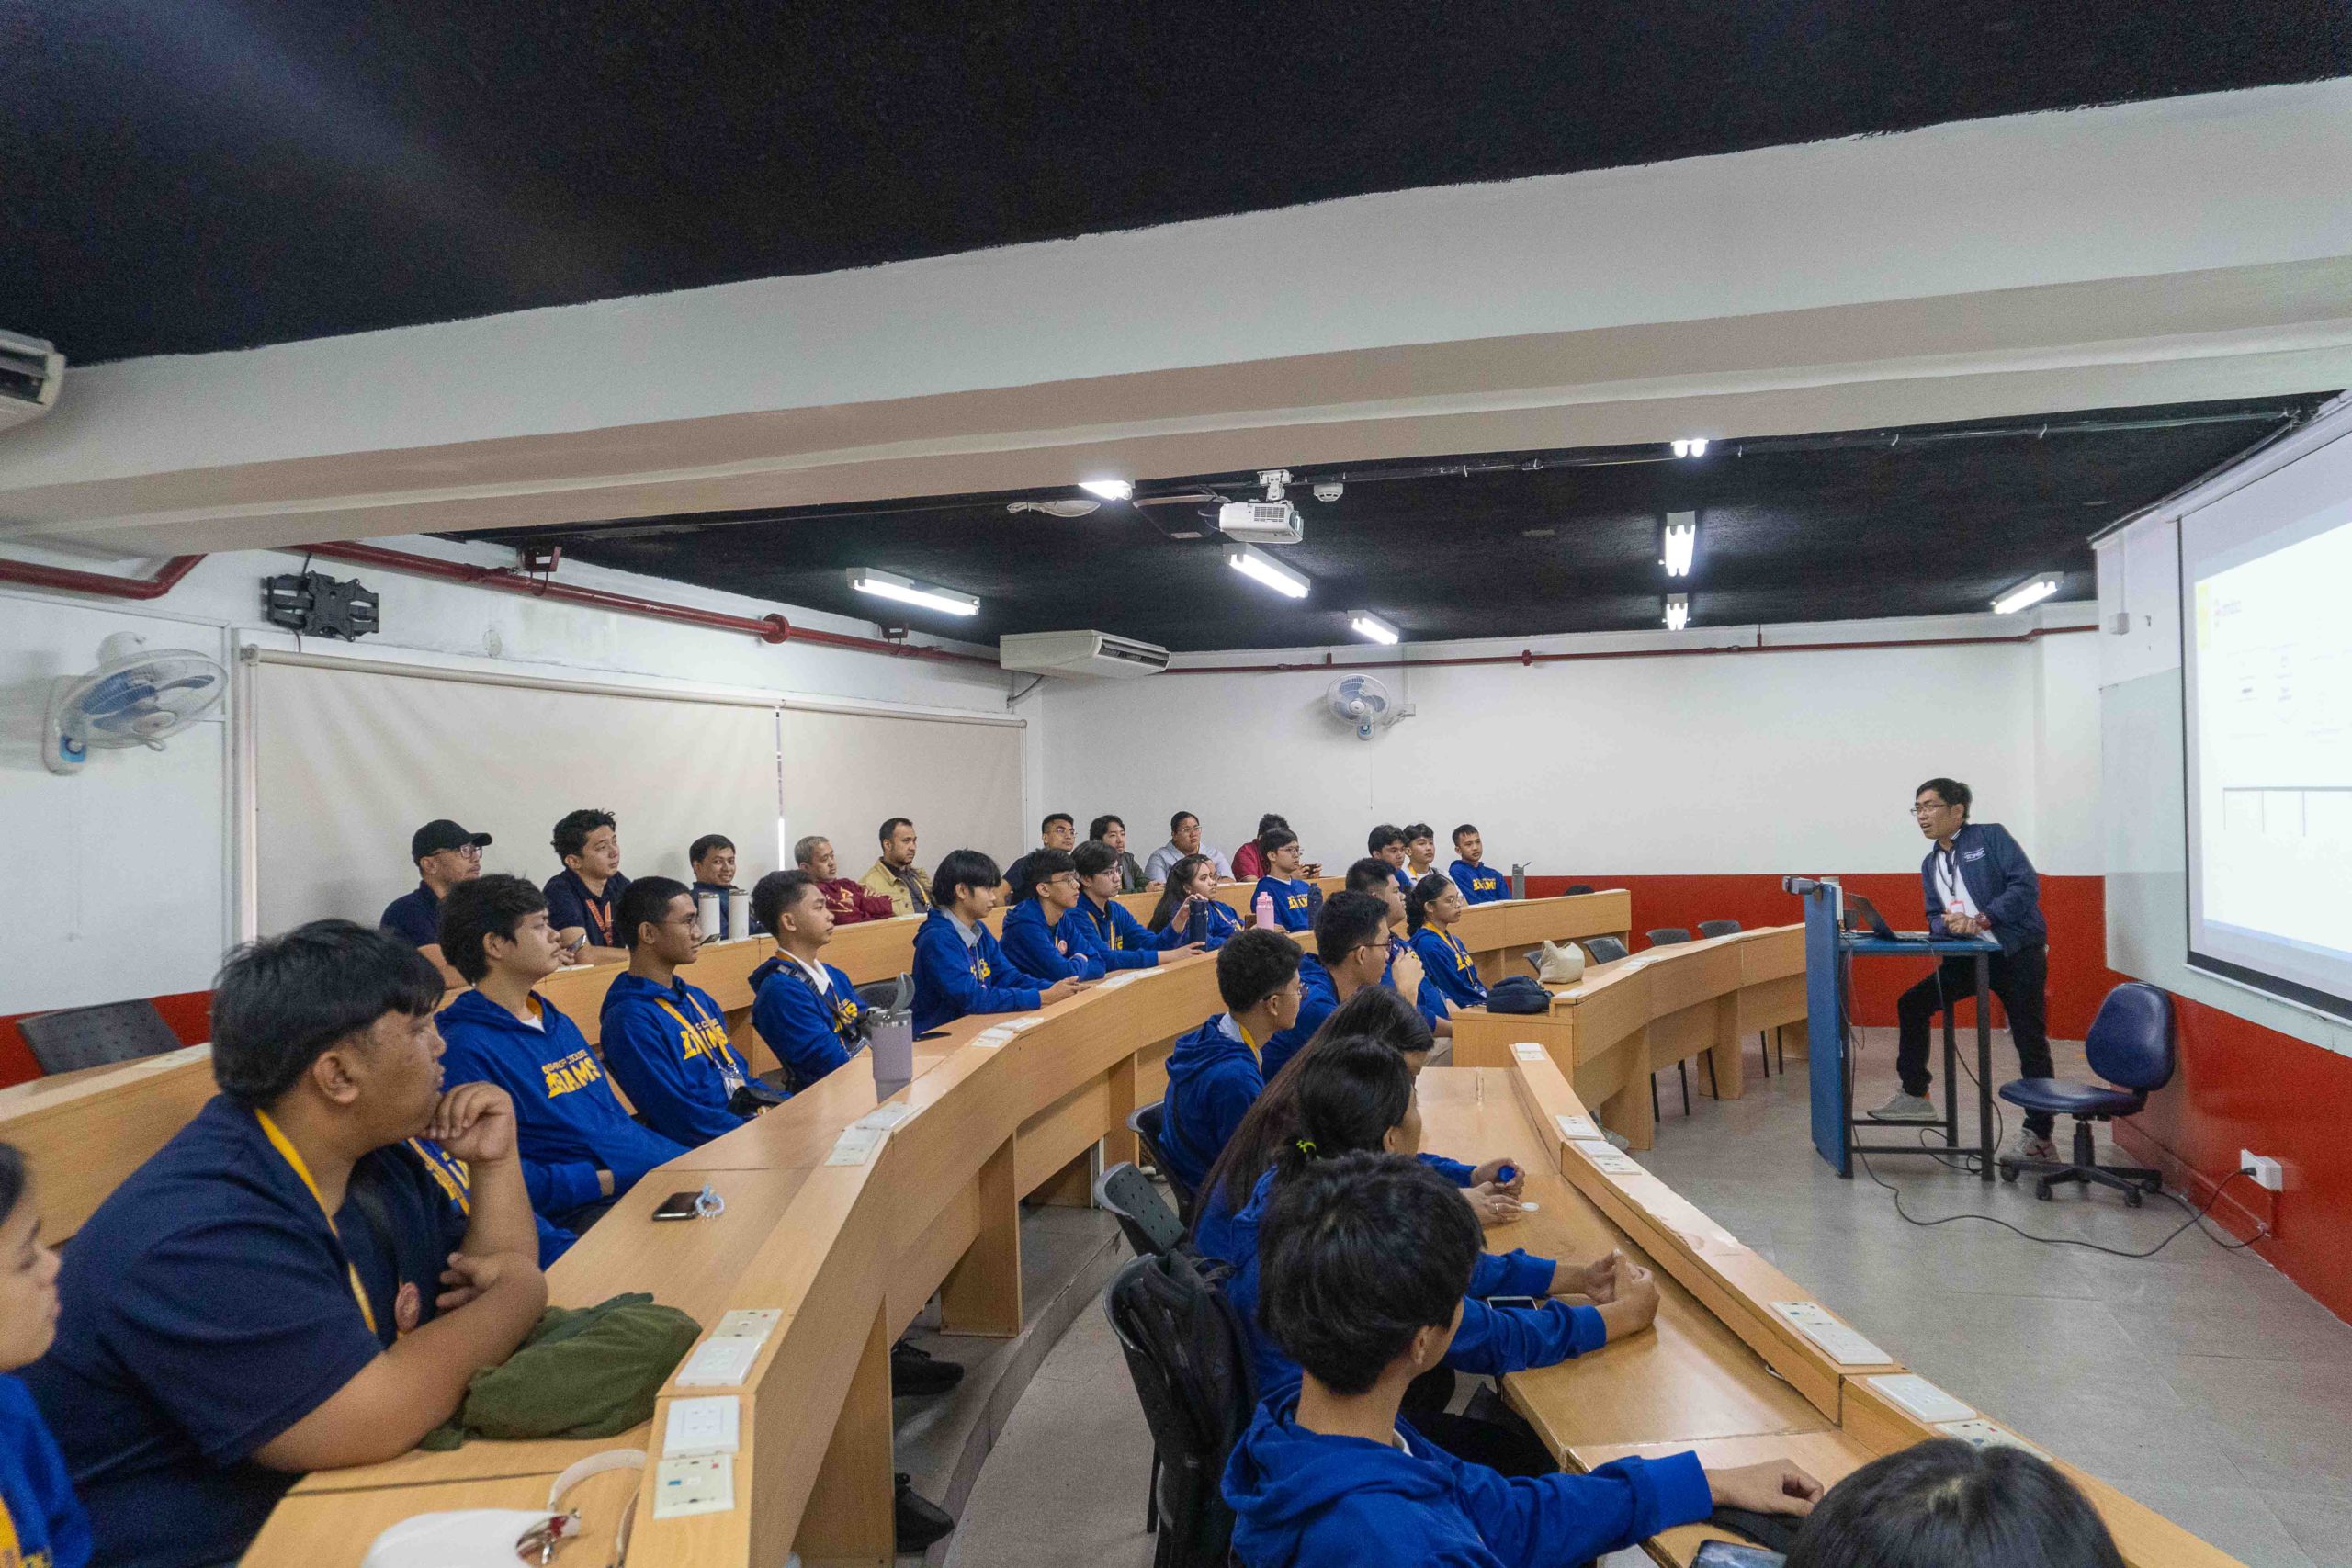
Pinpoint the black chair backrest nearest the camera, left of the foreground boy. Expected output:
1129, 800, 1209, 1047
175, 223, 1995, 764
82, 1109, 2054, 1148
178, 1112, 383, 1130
1103, 1251, 1259, 1568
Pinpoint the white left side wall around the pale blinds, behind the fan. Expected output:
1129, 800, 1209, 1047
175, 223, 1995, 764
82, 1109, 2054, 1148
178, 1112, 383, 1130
0, 538, 1040, 1016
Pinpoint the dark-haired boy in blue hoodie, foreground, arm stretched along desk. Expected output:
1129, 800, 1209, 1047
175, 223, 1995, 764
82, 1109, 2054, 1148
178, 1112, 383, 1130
1223, 1155, 1820, 1568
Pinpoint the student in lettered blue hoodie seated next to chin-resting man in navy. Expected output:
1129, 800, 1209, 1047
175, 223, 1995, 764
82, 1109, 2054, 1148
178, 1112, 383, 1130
440, 877, 687, 1232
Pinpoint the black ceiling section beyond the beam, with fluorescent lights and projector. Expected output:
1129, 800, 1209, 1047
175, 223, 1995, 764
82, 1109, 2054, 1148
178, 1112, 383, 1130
454, 395, 2322, 651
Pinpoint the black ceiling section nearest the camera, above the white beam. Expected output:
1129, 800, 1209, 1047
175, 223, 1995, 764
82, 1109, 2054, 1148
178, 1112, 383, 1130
0, 0, 2352, 362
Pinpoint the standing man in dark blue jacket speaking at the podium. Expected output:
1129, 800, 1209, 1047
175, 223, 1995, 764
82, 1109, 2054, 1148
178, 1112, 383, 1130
1870, 778, 2058, 1159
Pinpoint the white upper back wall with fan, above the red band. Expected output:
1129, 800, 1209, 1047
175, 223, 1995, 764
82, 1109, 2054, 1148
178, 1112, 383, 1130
1042, 606, 2098, 874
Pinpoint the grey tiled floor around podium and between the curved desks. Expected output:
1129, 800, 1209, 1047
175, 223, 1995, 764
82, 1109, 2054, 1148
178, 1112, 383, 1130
948, 1032, 2352, 1568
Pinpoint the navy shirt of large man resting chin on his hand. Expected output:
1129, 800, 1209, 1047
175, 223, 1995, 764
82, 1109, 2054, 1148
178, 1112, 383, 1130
24, 1096, 463, 1568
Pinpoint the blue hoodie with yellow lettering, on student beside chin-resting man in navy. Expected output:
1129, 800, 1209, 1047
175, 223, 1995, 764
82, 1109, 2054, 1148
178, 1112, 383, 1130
435, 992, 687, 1229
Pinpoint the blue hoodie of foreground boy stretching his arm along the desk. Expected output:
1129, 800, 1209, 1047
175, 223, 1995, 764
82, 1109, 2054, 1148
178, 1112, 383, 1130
1223, 1396, 1714, 1568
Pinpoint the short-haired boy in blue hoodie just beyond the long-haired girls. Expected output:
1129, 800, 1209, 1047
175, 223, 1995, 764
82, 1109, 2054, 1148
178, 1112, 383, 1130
1159, 931, 1298, 1192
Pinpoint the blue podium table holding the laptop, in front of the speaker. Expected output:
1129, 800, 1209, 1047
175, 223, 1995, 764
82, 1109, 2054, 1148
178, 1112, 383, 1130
1804, 884, 2002, 1182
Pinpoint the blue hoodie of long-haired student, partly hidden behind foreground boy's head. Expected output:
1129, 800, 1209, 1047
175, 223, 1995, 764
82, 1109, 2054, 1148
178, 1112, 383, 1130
1193, 1170, 1609, 1410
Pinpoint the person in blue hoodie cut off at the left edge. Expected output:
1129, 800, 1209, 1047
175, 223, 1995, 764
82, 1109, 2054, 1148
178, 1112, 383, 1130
0, 1143, 89, 1568
